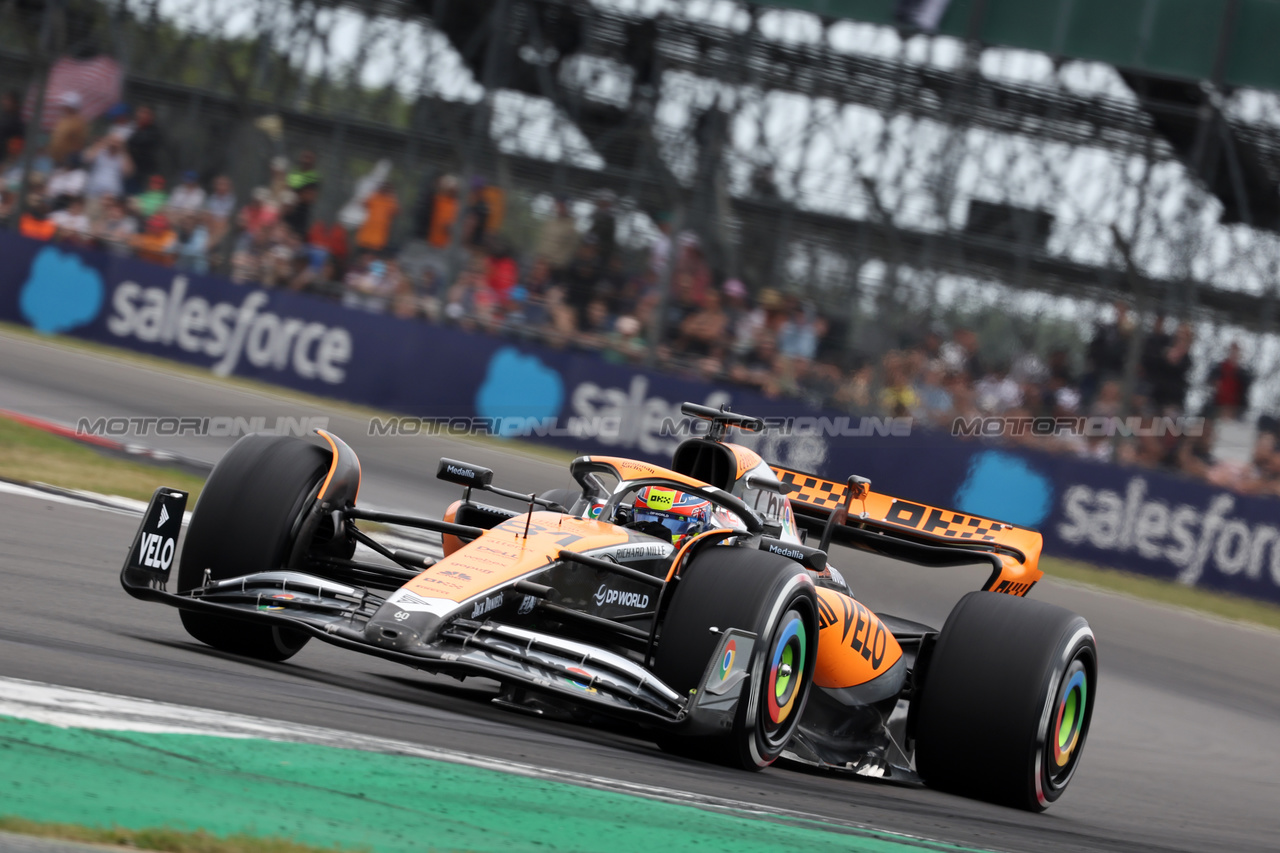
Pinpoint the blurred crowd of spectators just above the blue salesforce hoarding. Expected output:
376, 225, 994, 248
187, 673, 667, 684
0, 93, 1280, 496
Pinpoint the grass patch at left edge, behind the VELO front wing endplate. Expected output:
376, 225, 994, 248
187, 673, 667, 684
0, 409, 205, 506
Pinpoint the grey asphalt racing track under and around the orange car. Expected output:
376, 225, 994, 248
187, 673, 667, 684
0, 334, 1280, 852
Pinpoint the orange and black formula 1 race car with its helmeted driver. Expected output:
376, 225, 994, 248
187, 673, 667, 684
120, 403, 1097, 809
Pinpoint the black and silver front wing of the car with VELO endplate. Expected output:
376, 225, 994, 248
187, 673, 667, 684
120, 488, 754, 733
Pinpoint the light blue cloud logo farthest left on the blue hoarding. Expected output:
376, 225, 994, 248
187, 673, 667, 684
18, 246, 105, 334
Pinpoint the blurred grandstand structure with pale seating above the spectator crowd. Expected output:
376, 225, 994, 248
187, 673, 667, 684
0, 0, 1280, 330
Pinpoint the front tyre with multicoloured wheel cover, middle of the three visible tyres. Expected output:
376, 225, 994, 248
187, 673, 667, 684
654, 547, 818, 770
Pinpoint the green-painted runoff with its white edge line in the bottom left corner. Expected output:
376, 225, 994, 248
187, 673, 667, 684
0, 679, 974, 853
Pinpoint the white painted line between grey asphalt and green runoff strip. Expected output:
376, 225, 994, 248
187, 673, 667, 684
0, 678, 955, 847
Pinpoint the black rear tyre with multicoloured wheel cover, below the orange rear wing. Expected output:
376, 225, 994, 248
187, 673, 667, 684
914, 592, 1098, 811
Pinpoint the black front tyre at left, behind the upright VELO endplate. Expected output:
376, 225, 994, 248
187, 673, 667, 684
178, 433, 330, 661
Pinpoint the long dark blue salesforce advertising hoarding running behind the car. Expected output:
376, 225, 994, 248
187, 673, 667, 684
0, 233, 1280, 602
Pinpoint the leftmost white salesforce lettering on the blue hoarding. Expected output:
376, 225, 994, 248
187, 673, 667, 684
106, 275, 352, 384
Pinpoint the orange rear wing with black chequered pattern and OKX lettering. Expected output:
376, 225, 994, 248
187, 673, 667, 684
772, 466, 1044, 596
